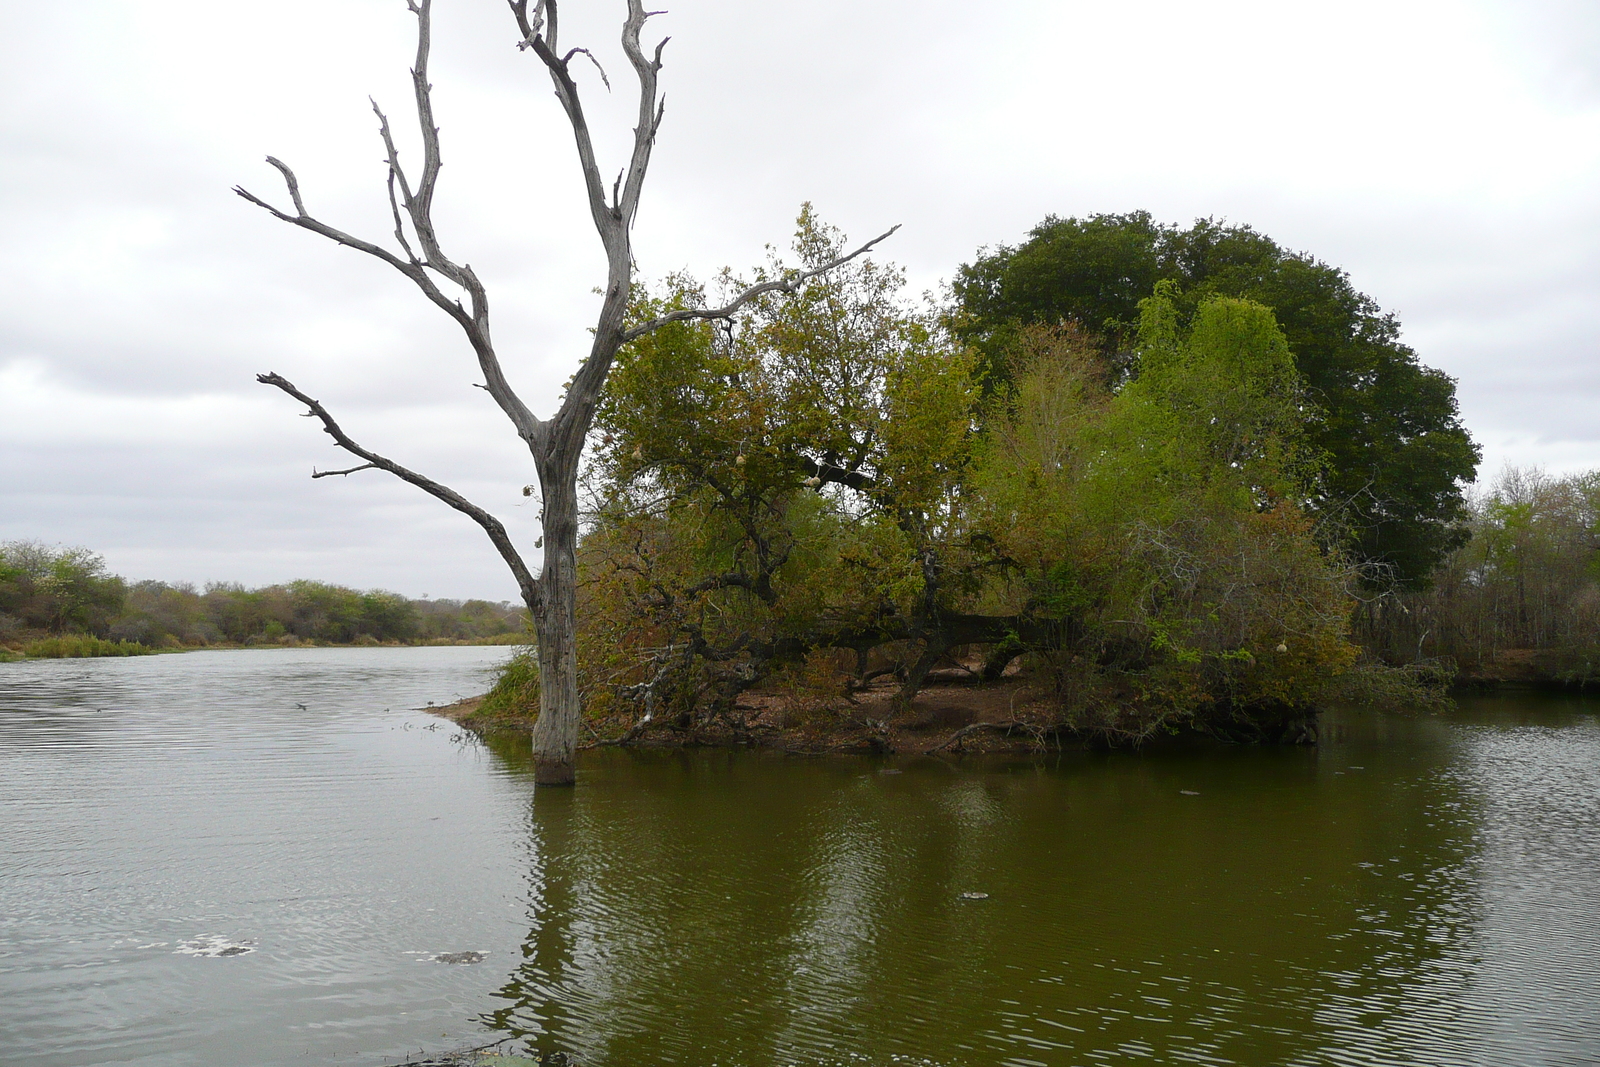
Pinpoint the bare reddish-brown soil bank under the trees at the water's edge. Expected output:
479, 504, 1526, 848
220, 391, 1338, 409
424, 667, 1056, 753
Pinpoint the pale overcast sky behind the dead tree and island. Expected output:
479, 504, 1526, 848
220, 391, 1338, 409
0, 0, 1600, 600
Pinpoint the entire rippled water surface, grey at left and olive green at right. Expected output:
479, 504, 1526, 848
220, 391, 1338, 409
0, 648, 1600, 1067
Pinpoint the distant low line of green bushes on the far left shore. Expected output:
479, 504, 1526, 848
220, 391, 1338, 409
0, 541, 526, 648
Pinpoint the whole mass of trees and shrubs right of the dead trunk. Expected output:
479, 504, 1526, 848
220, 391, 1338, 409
457, 210, 1600, 742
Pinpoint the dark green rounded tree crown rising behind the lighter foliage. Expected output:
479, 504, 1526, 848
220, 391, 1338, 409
952, 211, 1478, 584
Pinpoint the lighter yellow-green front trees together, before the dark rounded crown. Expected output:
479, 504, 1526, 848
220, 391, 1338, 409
581, 211, 1354, 739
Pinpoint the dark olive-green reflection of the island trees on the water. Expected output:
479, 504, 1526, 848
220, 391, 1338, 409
467, 728, 1477, 1064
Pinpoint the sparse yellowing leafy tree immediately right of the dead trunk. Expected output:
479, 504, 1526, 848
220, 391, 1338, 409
579, 208, 976, 726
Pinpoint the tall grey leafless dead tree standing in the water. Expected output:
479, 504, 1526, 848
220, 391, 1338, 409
234, 0, 899, 785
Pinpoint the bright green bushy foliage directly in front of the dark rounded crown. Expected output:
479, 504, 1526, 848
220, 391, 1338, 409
971, 286, 1354, 737
